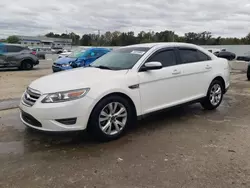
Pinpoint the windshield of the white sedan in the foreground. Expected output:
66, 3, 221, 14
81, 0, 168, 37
91, 47, 149, 70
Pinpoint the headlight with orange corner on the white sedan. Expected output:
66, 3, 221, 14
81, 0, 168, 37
42, 88, 89, 103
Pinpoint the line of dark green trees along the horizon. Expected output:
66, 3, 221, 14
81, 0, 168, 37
6, 30, 250, 46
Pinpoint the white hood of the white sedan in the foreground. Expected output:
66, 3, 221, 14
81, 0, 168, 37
29, 67, 128, 93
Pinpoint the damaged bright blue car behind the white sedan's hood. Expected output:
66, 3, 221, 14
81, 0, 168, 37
52, 48, 111, 72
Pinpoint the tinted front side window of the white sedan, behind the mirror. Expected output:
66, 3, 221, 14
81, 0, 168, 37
147, 50, 176, 67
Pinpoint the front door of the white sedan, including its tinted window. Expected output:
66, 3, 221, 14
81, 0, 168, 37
138, 48, 183, 114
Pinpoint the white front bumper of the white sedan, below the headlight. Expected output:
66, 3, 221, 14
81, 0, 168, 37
19, 96, 94, 132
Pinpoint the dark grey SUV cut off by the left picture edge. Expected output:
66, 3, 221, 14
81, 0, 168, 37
0, 44, 39, 70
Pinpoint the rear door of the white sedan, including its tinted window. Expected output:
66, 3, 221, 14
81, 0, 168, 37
177, 47, 213, 102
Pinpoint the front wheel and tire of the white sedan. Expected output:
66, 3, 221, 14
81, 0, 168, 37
88, 95, 135, 141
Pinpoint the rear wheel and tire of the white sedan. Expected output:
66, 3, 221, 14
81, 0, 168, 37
201, 80, 224, 110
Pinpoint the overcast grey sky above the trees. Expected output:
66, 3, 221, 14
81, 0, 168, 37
0, 0, 250, 37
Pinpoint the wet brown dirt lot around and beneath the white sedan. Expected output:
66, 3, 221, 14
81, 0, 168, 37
0, 63, 250, 188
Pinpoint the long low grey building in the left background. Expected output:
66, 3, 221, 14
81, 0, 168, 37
17, 36, 72, 48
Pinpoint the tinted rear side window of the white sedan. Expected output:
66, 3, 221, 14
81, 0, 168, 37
179, 49, 211, 63
